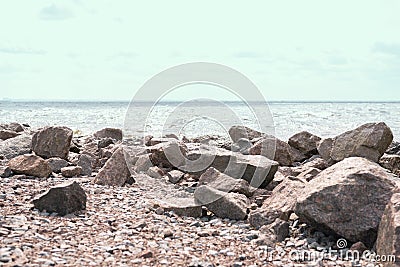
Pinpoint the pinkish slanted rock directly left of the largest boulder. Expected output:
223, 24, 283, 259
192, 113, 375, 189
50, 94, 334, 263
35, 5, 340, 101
249, 176, 307, 228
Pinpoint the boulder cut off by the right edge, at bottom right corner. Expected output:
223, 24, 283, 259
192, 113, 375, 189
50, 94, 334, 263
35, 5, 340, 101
376, 193, 400, 266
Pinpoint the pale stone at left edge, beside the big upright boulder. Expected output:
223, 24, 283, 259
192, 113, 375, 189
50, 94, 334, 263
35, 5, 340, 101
0, 134, 32, 159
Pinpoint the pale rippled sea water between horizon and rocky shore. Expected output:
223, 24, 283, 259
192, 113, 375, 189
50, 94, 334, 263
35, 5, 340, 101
0, 101, 400, 140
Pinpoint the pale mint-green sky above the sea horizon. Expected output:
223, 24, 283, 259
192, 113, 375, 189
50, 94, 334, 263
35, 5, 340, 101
0, 0, 400, 101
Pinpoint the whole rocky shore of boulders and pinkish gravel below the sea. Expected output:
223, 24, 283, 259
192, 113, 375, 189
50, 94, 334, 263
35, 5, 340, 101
0, 122, 400, 267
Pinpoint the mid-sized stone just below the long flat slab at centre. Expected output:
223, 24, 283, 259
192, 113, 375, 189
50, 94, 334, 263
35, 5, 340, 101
199, 167, 253, 197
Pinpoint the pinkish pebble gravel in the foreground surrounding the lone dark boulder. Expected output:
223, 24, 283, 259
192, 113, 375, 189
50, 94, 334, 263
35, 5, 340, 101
0, 176, 384, 267
